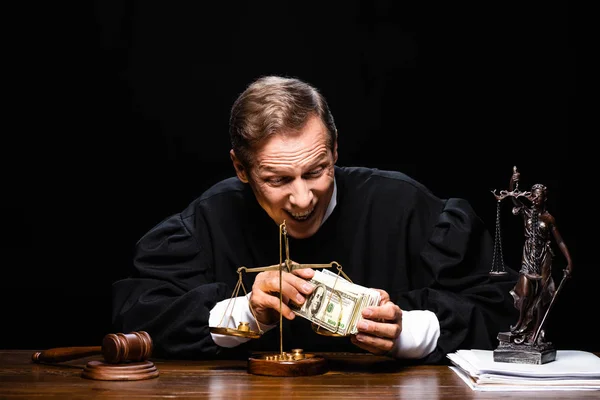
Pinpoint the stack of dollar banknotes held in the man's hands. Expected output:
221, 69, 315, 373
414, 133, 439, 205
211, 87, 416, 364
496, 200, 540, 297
289, 269, 380, 336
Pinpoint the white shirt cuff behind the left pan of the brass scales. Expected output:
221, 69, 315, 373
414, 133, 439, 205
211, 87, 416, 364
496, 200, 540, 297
208, 292, 277, 347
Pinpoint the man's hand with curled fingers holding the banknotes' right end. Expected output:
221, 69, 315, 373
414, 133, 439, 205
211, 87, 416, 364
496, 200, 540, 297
351, 289, 402, 355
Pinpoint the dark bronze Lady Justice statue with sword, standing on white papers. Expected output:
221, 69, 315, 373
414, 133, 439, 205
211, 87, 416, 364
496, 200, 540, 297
492, 167, 573, 364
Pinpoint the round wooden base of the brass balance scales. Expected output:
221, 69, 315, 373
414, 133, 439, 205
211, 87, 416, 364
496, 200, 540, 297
248, 349, 328, 376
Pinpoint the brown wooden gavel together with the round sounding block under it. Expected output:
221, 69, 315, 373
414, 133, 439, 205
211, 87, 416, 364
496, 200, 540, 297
32, 331, 159, 381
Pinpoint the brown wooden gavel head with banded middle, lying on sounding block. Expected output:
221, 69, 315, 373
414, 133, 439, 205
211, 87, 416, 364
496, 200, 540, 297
102, 331, 152, 364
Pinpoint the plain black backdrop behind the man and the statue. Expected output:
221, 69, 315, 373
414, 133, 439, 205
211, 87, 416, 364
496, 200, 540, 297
0, 0, 588, 350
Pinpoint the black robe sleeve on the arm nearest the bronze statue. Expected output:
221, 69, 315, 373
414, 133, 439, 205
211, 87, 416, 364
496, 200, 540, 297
398, 198, 517, 363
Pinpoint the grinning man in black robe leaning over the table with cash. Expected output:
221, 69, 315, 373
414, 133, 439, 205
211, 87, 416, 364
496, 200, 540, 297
113, 77, 514, 363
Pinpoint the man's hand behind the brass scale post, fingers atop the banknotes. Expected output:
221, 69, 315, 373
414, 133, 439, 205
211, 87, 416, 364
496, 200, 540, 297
250, 268, 315, 325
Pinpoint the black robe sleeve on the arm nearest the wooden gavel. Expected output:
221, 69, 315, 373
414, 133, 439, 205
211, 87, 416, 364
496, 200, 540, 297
112, 209, 231, 359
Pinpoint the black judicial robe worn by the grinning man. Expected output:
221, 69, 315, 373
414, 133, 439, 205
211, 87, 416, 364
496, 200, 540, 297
112, 166, 517, 364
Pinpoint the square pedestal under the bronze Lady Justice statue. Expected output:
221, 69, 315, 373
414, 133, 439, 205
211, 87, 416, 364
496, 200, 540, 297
494, 332, 556, 364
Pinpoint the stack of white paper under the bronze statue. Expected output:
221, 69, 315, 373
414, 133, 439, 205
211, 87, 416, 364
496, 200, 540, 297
447, 350, 600, 391
